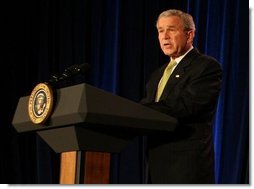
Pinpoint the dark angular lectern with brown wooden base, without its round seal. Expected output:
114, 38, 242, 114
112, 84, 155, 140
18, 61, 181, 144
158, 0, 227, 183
12, 83, 177, 184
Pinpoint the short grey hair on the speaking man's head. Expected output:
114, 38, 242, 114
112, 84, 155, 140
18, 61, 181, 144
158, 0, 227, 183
156, 9, 196, 31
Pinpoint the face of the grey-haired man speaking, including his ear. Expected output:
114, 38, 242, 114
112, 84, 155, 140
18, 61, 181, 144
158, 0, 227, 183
157, 16, 194, 58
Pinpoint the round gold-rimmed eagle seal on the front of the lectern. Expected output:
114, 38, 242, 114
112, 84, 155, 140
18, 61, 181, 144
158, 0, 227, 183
28, 83, 53, 124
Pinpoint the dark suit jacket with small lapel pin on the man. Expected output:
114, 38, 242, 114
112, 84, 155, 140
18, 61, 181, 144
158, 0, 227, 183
141, 49, 222, 184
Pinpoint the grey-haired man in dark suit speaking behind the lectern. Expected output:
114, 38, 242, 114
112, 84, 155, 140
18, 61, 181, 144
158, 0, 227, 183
141, 10, 222, 184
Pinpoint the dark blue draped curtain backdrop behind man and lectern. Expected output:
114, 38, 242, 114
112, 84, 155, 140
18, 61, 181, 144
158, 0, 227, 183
0, 0, 249, 184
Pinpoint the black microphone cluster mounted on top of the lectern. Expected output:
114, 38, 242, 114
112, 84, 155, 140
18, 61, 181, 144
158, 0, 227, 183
49, 63, 90, 85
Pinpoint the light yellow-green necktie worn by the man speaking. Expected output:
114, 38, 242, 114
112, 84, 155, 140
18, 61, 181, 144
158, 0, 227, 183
155, 60, 177, 102
